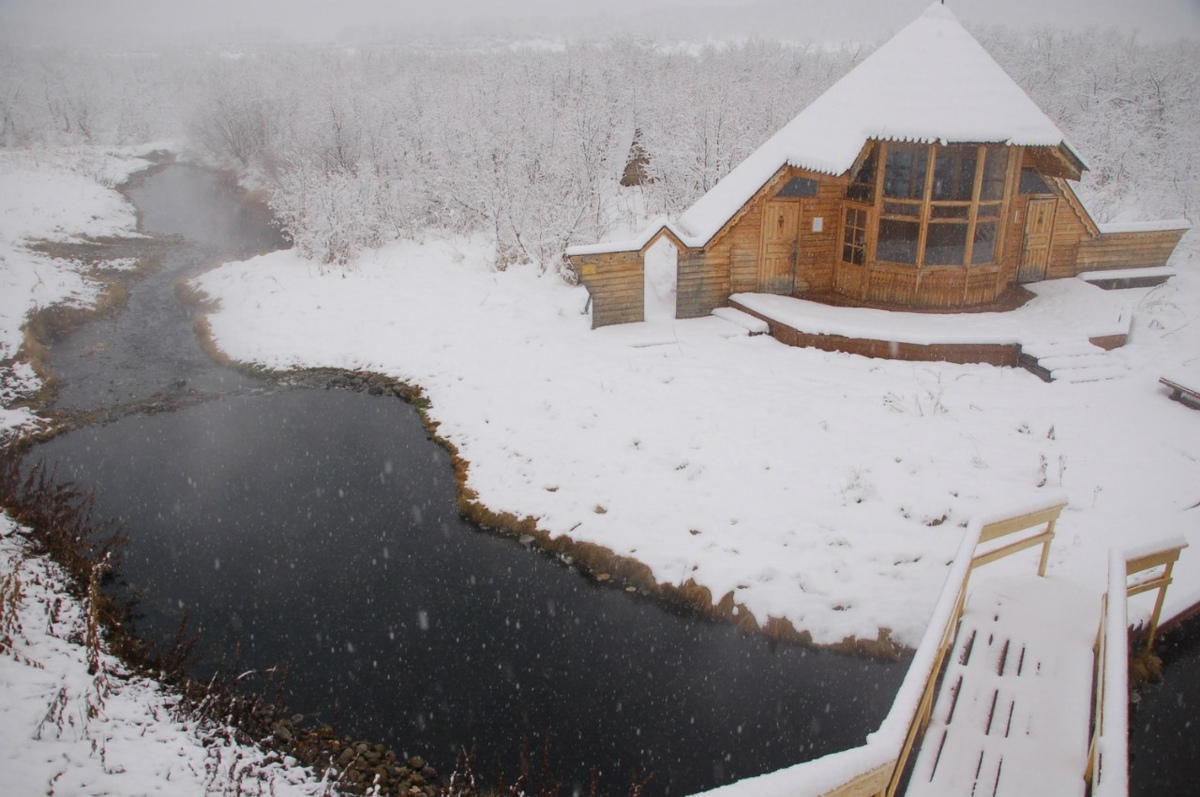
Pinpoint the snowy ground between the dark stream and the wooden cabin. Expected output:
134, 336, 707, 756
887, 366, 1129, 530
198, 230, 1200, 645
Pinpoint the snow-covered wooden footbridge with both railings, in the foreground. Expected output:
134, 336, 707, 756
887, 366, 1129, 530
691, 504, 1188, 797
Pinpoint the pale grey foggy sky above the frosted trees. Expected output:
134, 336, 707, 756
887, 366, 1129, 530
0, 0, 1200, 47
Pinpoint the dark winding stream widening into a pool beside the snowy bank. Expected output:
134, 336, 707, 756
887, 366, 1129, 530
25, 166, 905, 795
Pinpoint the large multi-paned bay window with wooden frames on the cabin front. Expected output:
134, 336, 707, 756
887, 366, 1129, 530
859, 142, 1009, 266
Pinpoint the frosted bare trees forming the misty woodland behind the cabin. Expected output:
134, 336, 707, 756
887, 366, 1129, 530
0, 30, 1200, 269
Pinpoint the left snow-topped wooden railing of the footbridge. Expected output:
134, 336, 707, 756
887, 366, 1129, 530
706, 497, 1066, 797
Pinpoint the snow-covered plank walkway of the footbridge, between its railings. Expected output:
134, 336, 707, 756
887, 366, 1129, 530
905, 576, 1099, 797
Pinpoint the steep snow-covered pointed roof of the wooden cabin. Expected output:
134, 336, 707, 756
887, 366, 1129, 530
678, 2, 1086, 245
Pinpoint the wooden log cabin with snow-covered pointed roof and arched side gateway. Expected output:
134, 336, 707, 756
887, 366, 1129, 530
566, 4, 1188, 328
